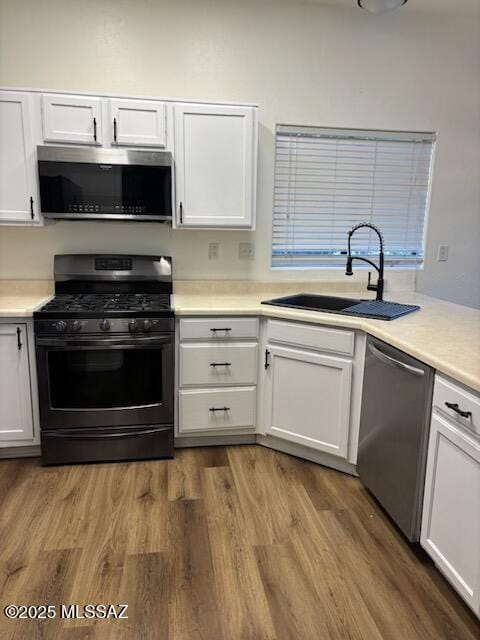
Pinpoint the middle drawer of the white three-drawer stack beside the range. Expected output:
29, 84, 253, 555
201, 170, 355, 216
180, 343, 257, 386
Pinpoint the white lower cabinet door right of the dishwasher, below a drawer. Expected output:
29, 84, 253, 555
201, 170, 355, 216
421, 413, 480, 615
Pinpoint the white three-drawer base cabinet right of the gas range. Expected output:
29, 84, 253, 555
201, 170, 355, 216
176, 317, 259, 439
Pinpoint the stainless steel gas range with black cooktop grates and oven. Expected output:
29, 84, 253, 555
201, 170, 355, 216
34, 254, 175, 464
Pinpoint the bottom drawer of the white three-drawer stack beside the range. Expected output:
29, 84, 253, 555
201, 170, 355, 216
179, 387, 256, 433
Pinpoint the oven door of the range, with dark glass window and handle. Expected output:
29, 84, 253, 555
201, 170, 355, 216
36, 334, 174, 430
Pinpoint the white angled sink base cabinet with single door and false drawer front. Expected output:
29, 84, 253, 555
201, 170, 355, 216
260, 319, 358, 464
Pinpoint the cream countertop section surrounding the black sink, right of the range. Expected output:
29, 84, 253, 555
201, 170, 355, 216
173, 289, 480, 392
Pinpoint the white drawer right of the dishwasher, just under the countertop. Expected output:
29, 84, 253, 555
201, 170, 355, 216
433, 375, 480, 436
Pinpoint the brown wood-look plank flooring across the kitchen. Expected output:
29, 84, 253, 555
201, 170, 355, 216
0, 445, 480, 640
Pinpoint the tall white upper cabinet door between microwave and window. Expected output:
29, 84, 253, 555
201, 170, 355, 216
175, 104, 257, 228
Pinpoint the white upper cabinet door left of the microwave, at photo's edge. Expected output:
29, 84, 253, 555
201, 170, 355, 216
0, 91, 38, 222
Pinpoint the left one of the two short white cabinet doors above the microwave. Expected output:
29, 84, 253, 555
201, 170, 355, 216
42, 94, 102, 145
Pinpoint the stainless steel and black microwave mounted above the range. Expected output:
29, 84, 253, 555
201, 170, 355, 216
37, 146, 172, 222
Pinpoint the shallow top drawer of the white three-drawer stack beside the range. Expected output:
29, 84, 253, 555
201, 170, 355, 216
180, 318, 258, 341
